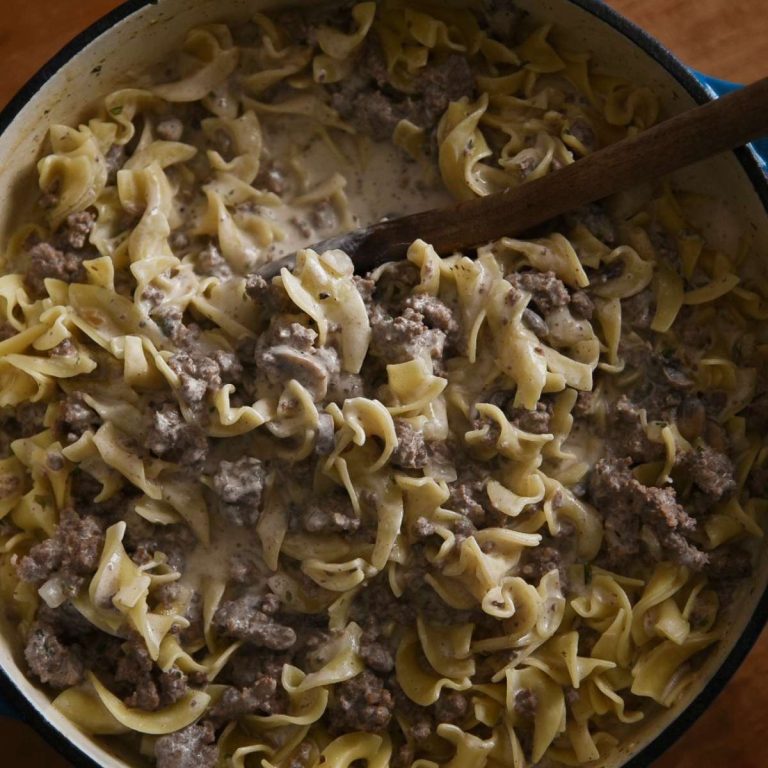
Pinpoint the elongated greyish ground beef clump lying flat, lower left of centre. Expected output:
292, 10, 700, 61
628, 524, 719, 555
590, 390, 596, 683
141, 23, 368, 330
213, 595, 296, 651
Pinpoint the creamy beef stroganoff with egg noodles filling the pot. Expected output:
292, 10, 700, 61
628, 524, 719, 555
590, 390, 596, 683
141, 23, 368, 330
0, 0, 768, 768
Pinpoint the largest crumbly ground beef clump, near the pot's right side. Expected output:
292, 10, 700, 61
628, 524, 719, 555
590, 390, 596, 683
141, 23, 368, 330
589, 459, 708, 570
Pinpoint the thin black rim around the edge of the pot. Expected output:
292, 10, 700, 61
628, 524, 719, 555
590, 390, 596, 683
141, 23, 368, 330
0, 0, 768, 768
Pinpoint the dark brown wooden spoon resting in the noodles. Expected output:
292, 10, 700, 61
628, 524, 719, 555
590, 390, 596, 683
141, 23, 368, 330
258, 78, 768, 277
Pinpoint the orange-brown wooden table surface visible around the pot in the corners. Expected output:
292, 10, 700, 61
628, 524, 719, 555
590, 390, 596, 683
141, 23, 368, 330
0, 0, 768, 768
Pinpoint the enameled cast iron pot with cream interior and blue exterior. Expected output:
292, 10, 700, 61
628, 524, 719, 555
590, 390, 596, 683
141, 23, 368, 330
0, 0, 768, 768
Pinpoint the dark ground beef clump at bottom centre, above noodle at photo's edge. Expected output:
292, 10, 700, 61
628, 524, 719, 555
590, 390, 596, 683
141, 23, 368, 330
328, 669, 395, 734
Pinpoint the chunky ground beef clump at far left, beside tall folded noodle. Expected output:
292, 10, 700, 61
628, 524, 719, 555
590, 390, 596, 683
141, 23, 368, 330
16, 508, 104, 595
